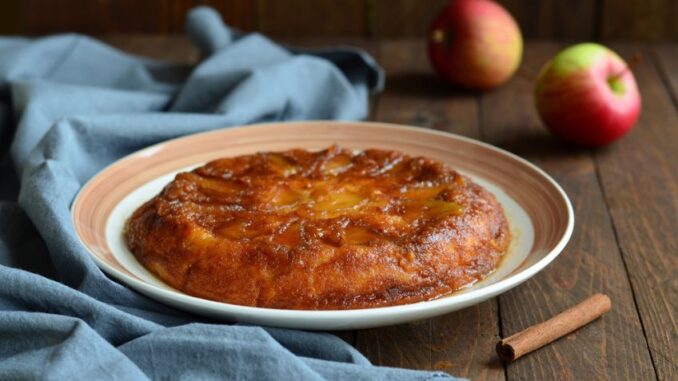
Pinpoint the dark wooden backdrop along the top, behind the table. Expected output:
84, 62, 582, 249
0, 0, 678, 41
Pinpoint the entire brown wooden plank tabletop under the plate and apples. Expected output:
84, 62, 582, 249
105, 36, 678, 380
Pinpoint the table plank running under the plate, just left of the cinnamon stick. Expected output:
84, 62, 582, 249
356, 40, 504, 380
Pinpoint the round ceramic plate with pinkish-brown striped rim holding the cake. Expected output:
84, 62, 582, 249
71, 121, 574, 330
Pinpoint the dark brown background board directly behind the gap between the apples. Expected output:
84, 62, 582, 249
498, 0, 602, 40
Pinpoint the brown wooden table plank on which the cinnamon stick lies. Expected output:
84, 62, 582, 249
481, 44, 655, 380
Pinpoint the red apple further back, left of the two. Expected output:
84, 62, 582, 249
428, 0, 523, 90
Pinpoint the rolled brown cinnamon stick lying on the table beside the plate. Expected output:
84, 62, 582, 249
497, 294, 612, 361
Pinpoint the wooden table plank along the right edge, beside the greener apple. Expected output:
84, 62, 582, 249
595, 45, 678, 380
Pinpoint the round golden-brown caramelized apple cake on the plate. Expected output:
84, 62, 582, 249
125, 147, 509, 310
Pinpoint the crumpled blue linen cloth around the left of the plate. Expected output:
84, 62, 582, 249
0, 8, 462, 381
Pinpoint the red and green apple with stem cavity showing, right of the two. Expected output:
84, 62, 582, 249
534, 43, 640, 147
